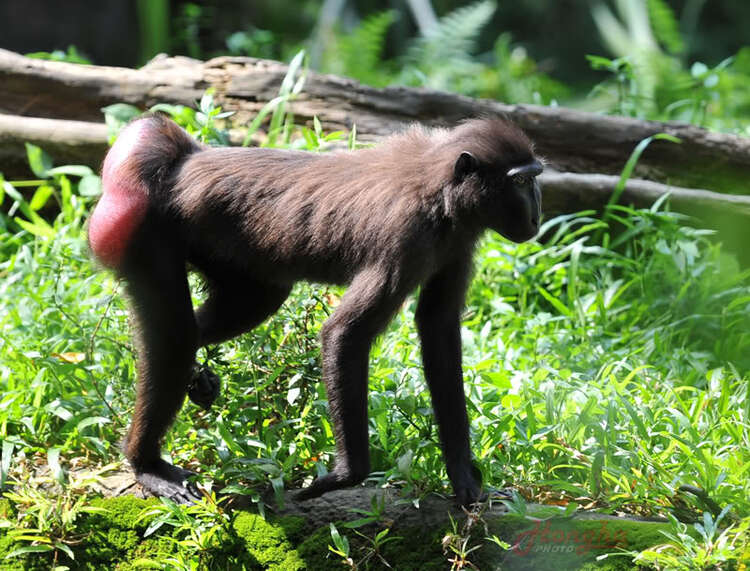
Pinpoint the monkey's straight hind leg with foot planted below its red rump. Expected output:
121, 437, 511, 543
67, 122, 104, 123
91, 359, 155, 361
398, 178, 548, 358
122, 228, 200, 503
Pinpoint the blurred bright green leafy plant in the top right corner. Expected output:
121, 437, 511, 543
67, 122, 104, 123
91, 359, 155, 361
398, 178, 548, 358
587, 0, 750, 132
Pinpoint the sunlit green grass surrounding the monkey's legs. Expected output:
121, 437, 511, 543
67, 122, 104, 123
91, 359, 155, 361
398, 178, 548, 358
0, 147, 750, 568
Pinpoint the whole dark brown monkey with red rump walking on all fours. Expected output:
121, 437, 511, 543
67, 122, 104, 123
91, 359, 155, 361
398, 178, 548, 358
89, 116, 542, 504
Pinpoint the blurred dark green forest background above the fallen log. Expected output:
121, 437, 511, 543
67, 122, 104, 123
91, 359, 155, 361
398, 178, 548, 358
0, 0, 750, 113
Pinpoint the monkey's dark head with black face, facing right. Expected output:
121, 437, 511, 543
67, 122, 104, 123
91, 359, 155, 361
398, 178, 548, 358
453, 120, 543, 242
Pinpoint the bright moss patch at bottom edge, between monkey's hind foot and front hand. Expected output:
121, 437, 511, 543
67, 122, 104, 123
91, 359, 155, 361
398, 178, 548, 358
232, 512, 306, 571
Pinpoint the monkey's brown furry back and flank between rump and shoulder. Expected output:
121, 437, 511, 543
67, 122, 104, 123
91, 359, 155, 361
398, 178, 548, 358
173, 147, 450, 283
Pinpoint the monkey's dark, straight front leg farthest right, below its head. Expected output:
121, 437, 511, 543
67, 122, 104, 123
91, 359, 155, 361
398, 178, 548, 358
416, 264, 481, 506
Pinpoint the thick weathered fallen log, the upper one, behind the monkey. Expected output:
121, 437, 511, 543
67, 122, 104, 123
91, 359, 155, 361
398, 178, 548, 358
0, 50, 750, 194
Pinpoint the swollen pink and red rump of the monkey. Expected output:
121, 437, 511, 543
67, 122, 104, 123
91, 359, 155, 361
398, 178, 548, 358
89, 115, 202, 269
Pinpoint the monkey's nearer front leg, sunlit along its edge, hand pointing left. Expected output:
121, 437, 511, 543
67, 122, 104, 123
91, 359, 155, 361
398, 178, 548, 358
297, 272, 400, 500
